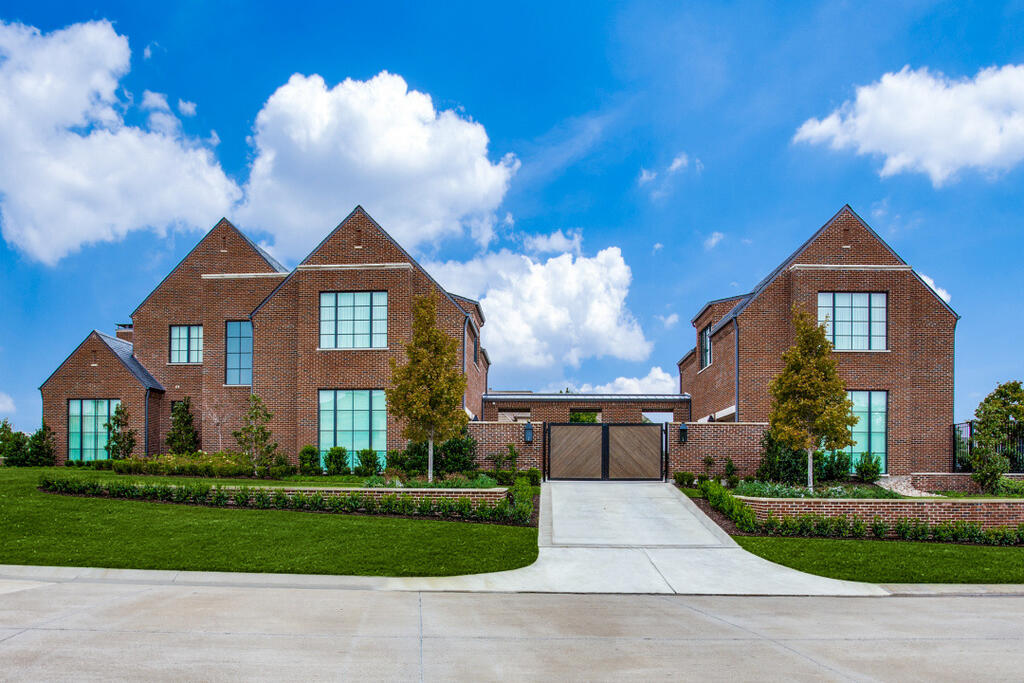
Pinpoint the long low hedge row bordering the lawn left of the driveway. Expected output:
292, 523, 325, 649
39, 476, 534, 524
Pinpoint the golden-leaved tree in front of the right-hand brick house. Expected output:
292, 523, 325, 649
769, 304, 857, 488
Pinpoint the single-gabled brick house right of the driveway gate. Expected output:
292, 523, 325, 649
678, 206, 958, 474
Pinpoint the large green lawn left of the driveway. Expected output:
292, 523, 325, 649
0, 467, 538, 577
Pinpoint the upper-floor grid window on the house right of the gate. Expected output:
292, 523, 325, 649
818, 292, 888, 351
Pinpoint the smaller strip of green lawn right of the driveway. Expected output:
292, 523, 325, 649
733, 536, 1024, 584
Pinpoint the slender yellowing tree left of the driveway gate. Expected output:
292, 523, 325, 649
387, 293, 468, 481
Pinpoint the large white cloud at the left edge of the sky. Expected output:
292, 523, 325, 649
0, 22, 241, 265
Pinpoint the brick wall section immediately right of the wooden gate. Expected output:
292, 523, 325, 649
669, 422, 768, 477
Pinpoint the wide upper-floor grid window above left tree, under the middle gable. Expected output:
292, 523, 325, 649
319, 292, 387, 348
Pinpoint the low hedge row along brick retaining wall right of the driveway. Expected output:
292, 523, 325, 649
700, 481, 1024, 546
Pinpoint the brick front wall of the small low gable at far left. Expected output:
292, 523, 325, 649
40, 333, 153, 464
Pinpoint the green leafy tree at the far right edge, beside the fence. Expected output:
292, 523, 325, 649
971, 381, 1024, 492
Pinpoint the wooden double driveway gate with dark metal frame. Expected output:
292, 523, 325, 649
545, 423, 666, 480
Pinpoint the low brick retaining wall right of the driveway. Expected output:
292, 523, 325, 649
736, 496, 1024, 536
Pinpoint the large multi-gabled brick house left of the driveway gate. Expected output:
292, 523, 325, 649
40, 207, 489, 461
